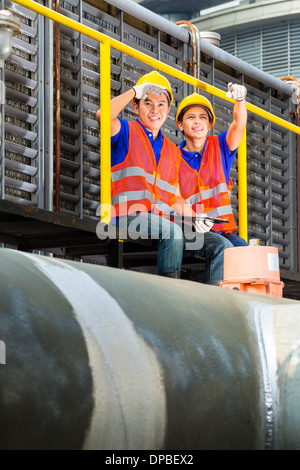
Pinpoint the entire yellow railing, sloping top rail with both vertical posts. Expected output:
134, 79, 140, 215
14, 0, 300, 239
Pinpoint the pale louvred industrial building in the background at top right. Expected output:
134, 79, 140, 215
134, 0, 300, 78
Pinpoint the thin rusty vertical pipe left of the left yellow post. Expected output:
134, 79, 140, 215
55, 0, 61, 212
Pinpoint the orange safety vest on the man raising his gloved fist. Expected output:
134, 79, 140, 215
179, 136, 236, 232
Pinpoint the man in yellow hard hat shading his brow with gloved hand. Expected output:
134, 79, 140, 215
97, 71, 210, 278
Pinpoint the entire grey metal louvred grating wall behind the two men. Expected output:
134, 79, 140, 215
1, 0, 298, 270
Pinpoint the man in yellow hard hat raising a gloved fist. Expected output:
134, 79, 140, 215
176, 83, 247, 285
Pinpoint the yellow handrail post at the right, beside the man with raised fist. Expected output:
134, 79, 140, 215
238, 130, 248, 242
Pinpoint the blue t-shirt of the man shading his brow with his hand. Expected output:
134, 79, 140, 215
111, 118, 163, 166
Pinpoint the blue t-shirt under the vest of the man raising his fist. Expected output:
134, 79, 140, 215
180, 131, 237, 184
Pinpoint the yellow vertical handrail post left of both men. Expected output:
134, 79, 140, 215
100, 41, 111, 224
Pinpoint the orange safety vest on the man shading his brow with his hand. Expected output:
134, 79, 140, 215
111, 121, 181, 216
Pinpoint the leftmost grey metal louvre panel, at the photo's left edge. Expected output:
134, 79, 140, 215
1, 2, 42, 206
